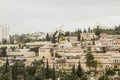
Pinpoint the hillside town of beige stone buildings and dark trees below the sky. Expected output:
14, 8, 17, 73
0, 25, 120, 80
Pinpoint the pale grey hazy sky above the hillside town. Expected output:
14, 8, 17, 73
0, 0, 120, 34
